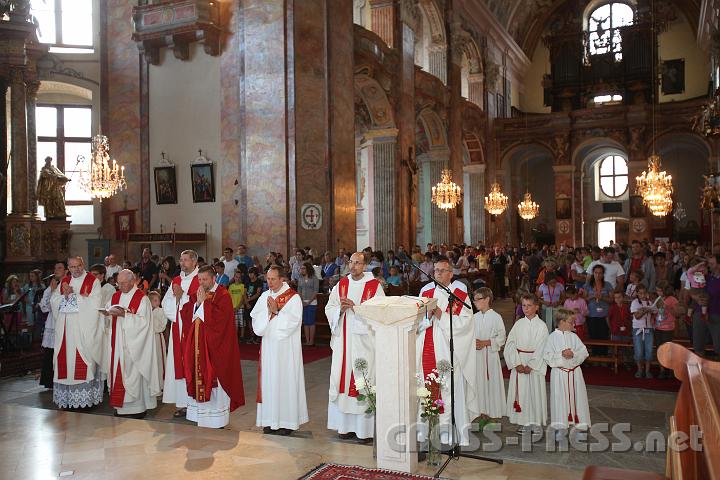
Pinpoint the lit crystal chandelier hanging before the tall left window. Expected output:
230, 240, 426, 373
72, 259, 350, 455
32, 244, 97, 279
78, 135, 127, 201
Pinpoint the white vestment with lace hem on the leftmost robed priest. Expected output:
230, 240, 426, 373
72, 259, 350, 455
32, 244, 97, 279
50, 272, 104, 408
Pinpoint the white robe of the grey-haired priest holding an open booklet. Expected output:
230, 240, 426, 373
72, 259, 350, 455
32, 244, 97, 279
105, 287, 160, 415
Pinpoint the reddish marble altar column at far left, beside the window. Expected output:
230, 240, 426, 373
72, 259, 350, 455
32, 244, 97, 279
10, 69, 29, 216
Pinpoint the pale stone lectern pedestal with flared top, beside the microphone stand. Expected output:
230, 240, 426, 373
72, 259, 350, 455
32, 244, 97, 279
355, 297, 437, 473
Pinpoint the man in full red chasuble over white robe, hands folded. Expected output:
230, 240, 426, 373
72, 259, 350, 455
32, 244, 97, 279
180, 265, 245, 428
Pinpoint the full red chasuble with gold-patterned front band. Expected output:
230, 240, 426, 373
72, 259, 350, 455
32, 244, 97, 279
180, 285, 245, 411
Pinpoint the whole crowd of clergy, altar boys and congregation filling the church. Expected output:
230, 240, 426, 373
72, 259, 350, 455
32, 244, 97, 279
2, 242, 720, 444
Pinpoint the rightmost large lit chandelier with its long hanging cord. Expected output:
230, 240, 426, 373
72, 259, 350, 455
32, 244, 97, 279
635, 2, 673, 217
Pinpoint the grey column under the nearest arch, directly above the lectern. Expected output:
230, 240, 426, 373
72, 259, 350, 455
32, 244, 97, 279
365, 129, 397, 252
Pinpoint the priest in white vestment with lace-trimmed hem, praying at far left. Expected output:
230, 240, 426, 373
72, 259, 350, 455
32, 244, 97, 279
50, 257, 104, 408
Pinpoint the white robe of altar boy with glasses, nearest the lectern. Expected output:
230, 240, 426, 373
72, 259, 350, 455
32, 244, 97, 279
473, 308, 506, 418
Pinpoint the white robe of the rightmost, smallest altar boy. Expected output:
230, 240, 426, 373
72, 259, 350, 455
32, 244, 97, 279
544, 330, 590, 428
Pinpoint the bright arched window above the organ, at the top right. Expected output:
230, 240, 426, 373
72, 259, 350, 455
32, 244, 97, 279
587, 2, 635, 61
